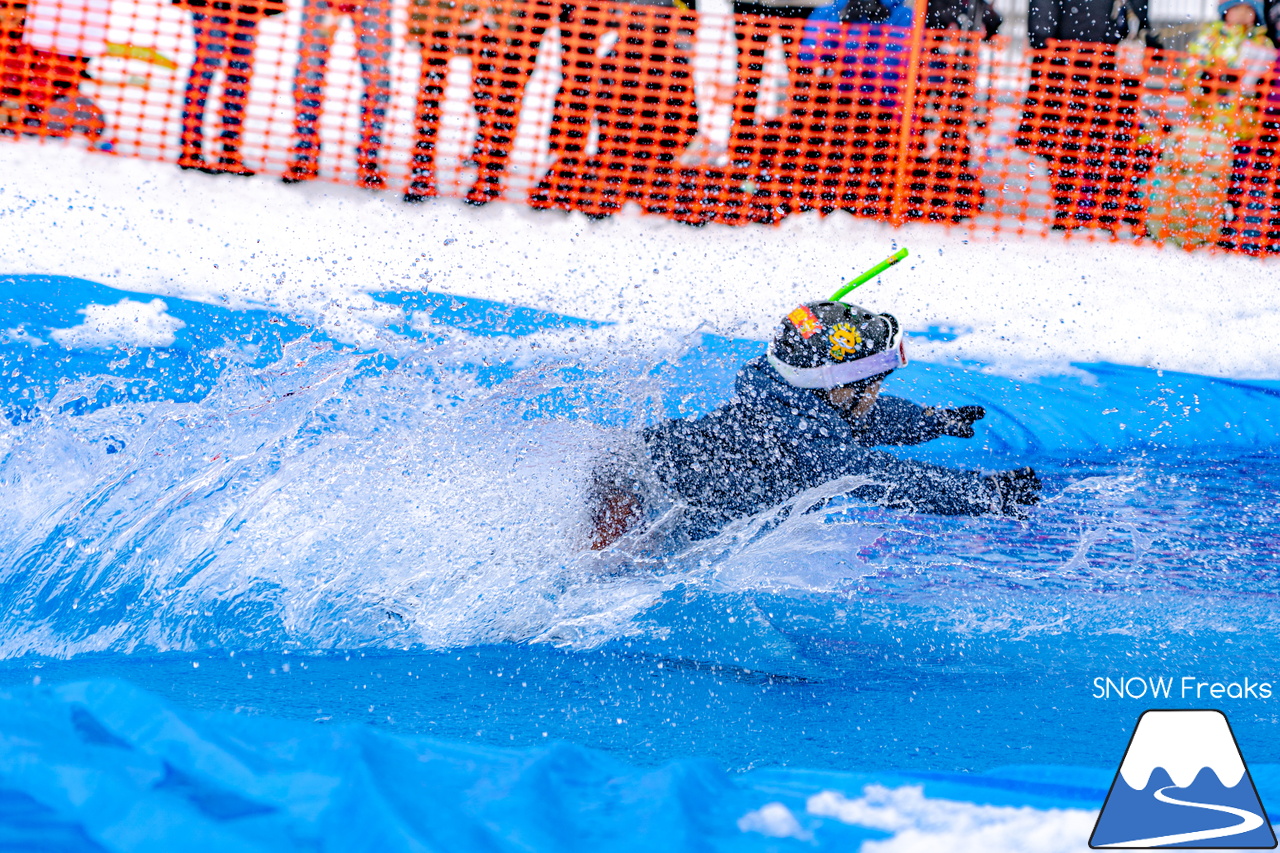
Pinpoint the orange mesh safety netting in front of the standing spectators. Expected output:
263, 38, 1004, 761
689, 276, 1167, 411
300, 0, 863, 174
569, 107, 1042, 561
0, 0, 1280, 252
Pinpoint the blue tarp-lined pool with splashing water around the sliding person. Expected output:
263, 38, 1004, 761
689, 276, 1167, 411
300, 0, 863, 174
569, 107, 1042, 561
0, 277, 1280, 849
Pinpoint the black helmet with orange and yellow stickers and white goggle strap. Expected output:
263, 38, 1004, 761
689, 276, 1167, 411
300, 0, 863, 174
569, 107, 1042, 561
769, 302, 906, 388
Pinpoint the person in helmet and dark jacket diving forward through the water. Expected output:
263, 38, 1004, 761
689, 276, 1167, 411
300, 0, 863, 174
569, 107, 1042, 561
589, 301, 1041, 551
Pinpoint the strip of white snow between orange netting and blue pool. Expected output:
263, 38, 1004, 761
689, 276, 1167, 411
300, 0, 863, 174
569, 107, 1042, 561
0, 143, 1280, 379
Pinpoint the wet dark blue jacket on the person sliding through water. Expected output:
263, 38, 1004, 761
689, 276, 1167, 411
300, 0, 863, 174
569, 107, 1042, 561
644, 357, 1000, 538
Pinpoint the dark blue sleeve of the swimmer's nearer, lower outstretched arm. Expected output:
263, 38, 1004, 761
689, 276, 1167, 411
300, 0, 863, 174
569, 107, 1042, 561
849, 451, 1000, 515
